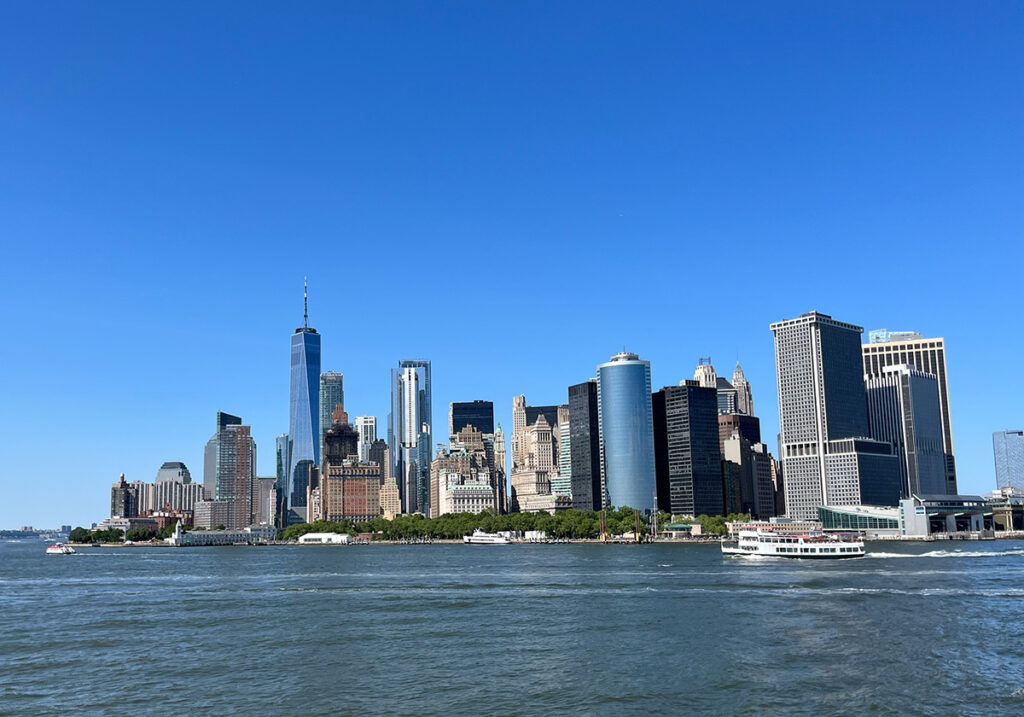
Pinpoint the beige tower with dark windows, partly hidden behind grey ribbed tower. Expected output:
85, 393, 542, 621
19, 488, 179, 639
861, 329, 956, 495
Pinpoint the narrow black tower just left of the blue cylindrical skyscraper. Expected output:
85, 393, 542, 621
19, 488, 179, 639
569, 378, 603, 510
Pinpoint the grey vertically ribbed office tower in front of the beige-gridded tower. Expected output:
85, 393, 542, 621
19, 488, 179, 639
865, 364, 948, 498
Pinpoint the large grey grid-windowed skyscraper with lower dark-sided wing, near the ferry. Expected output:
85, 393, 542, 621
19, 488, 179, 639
771, 311, 899, 520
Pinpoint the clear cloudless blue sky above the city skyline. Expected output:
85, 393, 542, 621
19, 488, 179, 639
0, 1, 1024, 528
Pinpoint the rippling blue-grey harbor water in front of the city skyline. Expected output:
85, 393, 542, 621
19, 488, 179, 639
0, 541, 1024, 715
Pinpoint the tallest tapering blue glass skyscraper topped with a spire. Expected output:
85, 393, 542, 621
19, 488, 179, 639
288, 283, 321, 514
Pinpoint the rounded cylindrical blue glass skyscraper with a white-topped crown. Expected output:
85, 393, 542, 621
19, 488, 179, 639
597, 351, 656, 511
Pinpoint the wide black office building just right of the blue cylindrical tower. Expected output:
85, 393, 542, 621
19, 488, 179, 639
651, 381, 720, 516
